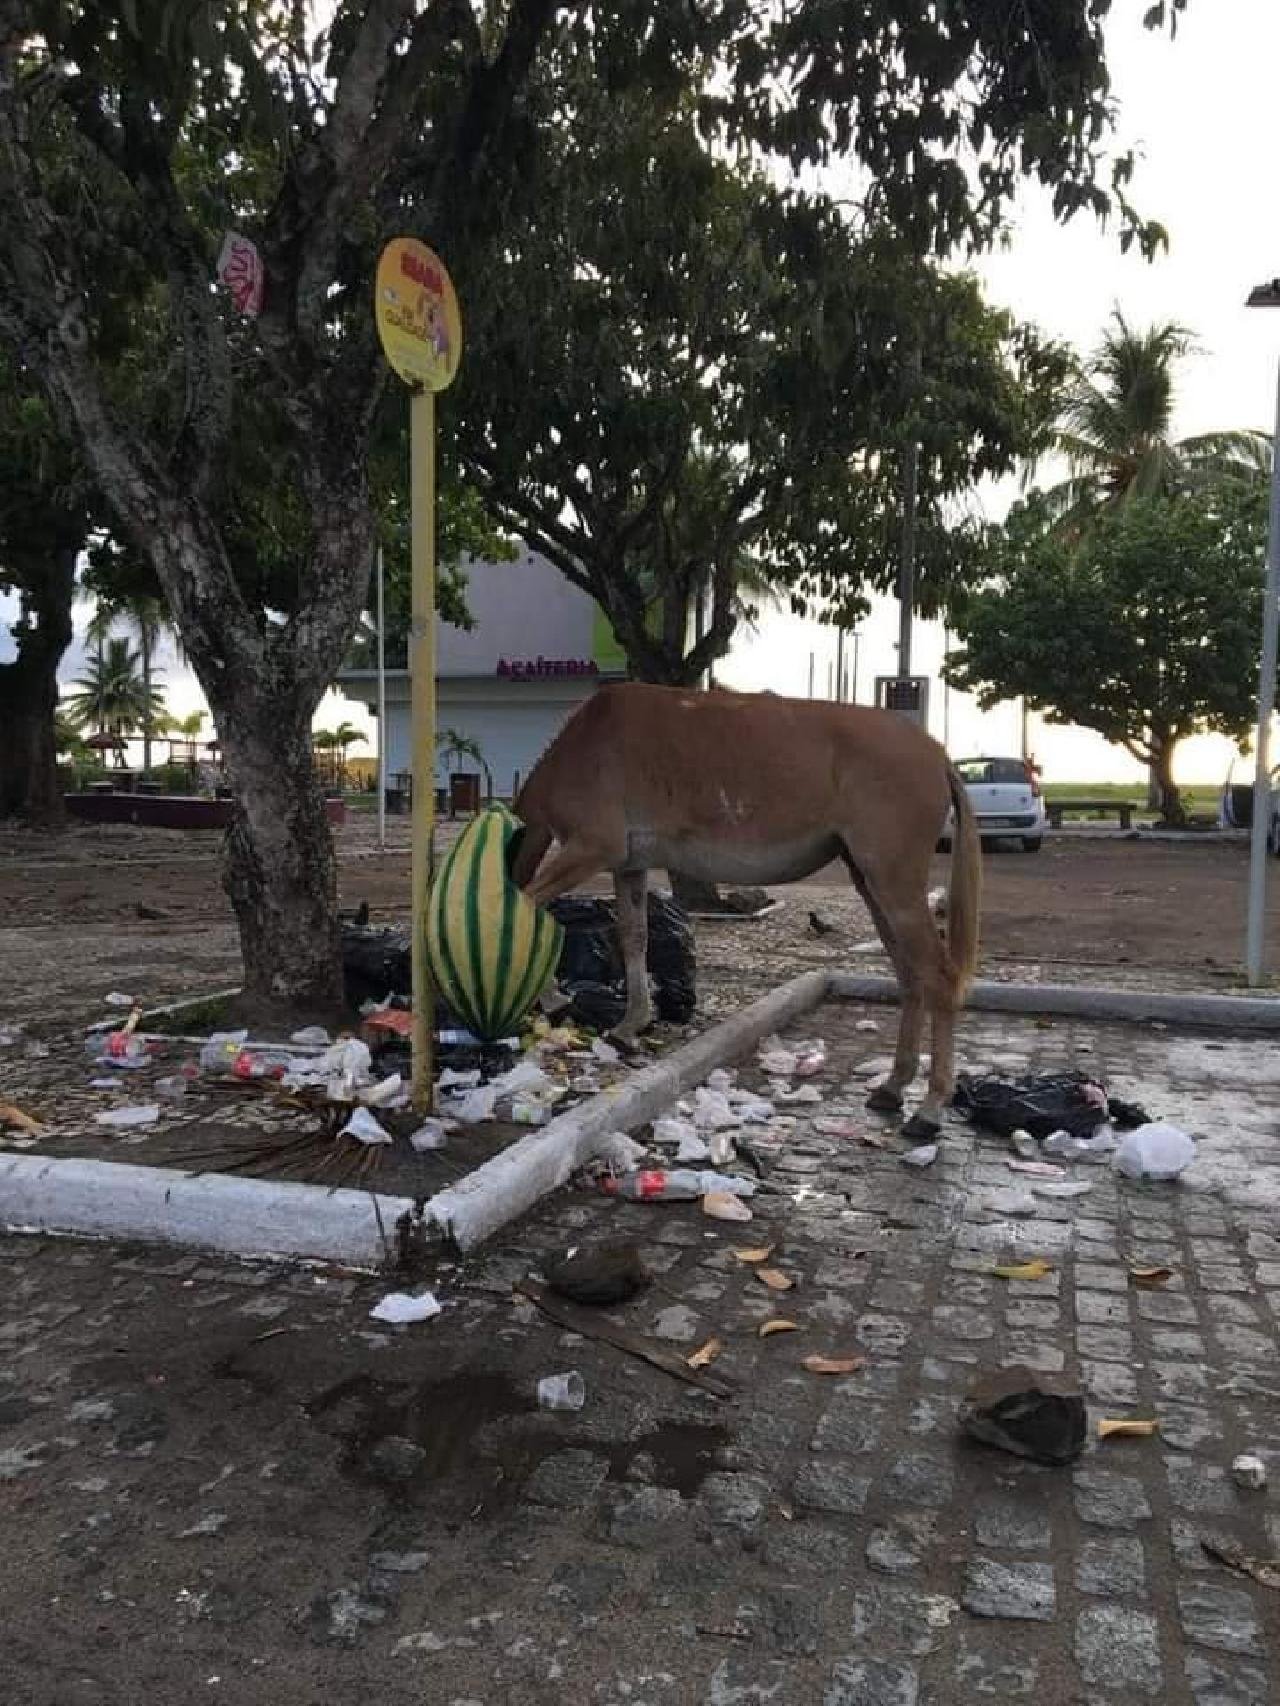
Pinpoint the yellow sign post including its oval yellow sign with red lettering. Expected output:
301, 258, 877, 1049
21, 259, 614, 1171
374, 237, 463, 1109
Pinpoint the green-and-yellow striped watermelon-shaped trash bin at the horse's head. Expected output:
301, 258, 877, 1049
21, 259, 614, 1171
427, 805, 565, 1042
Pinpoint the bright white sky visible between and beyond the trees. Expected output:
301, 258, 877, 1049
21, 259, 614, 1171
10, 0, 1280, 781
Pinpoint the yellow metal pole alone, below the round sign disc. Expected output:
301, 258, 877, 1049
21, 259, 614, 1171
410, 391, 435, 1111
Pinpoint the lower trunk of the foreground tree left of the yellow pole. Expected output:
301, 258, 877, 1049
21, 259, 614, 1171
215, 693, 343, 1017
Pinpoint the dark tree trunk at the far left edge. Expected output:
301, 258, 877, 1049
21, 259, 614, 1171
0, 544, 80, 829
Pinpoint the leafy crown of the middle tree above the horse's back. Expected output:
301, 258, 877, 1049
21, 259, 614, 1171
456, 65, 1067, 682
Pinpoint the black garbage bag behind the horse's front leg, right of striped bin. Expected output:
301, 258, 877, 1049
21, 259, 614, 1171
548, 894, 698, 1030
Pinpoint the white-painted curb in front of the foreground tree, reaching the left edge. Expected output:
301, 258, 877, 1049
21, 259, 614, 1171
0, 1155, 413, 1268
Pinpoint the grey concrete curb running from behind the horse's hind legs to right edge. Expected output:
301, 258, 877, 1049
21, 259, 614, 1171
826, 971, 1280, 1030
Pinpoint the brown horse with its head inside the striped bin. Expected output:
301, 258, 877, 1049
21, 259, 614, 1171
514, 684, 981, 1136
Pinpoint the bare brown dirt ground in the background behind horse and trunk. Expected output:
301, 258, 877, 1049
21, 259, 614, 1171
0, 821, 1280, 1027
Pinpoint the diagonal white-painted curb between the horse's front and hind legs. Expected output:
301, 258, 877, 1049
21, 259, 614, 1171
423, 971, 828, 1250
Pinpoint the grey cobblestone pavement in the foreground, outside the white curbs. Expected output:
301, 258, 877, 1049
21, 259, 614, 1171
0, 1008, 1280, 1706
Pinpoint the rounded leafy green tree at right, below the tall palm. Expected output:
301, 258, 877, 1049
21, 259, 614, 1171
947, 481, 1266, 819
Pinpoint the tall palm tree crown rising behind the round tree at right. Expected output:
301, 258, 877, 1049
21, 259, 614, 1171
1046, 309, 1270, 537
